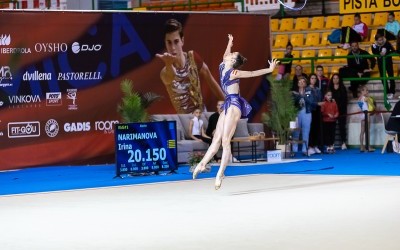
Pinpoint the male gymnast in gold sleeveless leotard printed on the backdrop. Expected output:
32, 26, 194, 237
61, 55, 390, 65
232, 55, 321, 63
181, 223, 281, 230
156, 19, 224, 114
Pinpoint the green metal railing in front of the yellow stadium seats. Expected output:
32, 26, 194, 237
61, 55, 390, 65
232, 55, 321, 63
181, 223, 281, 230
278, 53, 400, 110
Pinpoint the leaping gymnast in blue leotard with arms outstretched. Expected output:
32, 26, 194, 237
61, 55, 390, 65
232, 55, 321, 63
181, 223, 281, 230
193, 34, 278, 189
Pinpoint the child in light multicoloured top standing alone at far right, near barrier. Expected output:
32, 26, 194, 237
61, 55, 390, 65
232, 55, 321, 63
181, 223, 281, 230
358, 86, 375, 152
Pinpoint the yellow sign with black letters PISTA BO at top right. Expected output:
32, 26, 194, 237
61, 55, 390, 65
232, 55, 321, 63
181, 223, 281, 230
339, 0, 400, 14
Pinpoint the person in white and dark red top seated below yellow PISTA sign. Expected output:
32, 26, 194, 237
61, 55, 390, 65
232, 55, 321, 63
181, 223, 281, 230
339, 13, 368, 49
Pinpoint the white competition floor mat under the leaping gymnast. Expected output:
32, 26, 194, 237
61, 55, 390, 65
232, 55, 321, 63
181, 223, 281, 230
0, 175, 400, 250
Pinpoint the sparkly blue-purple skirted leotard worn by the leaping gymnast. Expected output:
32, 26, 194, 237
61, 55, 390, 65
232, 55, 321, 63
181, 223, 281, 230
219, 63, 251, 117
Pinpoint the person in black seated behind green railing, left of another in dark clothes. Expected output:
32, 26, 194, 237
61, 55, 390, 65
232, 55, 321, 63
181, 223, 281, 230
339, 42, 376, 98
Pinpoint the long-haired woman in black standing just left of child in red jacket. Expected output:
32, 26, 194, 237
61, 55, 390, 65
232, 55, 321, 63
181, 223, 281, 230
308, 74, 323, 155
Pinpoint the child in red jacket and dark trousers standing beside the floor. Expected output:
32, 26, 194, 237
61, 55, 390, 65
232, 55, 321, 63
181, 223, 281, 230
321, 90, 339, 153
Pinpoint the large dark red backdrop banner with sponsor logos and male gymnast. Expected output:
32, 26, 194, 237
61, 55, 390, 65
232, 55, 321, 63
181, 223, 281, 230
0, 11, 270, 170
